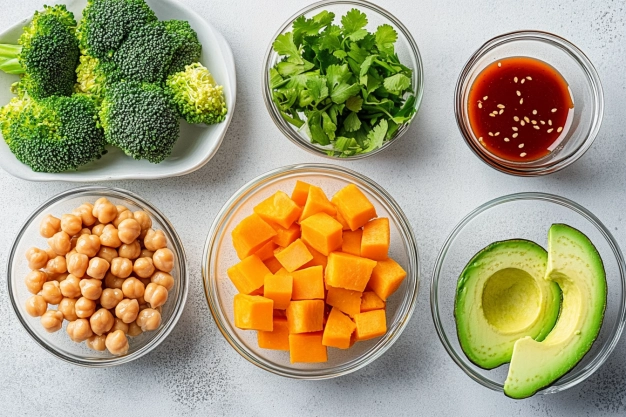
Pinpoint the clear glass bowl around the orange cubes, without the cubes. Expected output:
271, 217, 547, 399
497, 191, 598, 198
202, 164, 419, 379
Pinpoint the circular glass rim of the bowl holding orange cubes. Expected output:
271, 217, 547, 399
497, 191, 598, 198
201, 164, 421, 380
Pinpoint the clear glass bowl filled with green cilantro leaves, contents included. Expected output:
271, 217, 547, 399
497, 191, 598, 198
263, 1, 423, 159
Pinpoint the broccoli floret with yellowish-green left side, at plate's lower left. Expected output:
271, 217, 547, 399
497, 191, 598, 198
0, 94, 106, 172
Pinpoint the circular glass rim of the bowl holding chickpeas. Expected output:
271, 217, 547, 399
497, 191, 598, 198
7, 186, 189, 368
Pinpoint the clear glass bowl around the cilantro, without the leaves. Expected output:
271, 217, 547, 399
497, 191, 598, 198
262, 0, 424, 160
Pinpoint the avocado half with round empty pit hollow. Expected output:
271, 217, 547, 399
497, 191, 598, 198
454, 239, 561, 369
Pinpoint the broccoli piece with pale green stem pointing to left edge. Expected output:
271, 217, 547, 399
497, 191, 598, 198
0, 5, 80, 99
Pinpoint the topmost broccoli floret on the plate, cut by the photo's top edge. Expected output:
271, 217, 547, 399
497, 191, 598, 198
77, 0, 157, 60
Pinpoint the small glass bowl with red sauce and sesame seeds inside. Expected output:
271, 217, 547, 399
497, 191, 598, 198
455, 31, 604, 176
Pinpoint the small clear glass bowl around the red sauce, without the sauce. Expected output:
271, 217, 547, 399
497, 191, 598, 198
454, 31, 604, 176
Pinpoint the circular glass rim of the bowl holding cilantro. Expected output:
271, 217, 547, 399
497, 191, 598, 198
261, 0, 424, 161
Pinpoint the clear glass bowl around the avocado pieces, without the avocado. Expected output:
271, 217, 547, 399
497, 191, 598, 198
430, 193, 626, 394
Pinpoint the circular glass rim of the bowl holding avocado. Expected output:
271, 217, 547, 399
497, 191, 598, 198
430, 192, 626, 395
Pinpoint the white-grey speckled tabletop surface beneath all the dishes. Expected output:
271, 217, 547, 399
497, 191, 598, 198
0, 0, 626, 416
